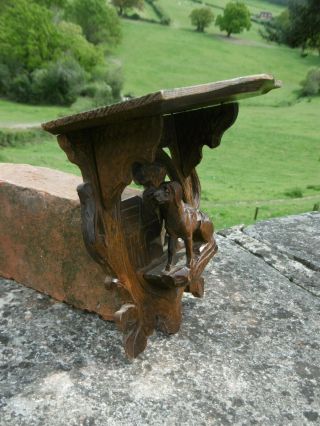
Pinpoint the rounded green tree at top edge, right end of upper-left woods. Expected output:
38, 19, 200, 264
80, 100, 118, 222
66, 0, 121, 45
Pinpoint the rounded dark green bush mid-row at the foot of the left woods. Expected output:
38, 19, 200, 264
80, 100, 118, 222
32, 57, 85, 105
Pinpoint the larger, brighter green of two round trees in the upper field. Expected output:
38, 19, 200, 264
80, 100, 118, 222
216, 2, 251, 37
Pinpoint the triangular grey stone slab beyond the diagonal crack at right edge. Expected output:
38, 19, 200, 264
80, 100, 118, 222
221, 212, 320, 296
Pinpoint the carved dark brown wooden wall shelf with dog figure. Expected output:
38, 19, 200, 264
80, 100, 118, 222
43, 74, 280, 357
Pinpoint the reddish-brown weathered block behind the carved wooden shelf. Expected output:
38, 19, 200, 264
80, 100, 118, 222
0, 164, 139, 319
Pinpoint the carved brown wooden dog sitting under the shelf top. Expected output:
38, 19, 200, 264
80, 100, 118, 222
153, 182, 213, 271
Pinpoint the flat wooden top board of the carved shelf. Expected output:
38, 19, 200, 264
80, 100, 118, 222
42, 74, 281, 135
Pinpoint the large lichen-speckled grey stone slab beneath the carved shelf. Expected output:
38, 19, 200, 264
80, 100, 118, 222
0, 216, 320, 426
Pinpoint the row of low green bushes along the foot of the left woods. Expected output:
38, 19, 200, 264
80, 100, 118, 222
4, 56, 123, 107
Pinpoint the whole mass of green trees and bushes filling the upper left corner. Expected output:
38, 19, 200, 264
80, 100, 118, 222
0, 0, 122, 107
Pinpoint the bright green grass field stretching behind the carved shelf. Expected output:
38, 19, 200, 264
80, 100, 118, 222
0, 0, 320, 228
